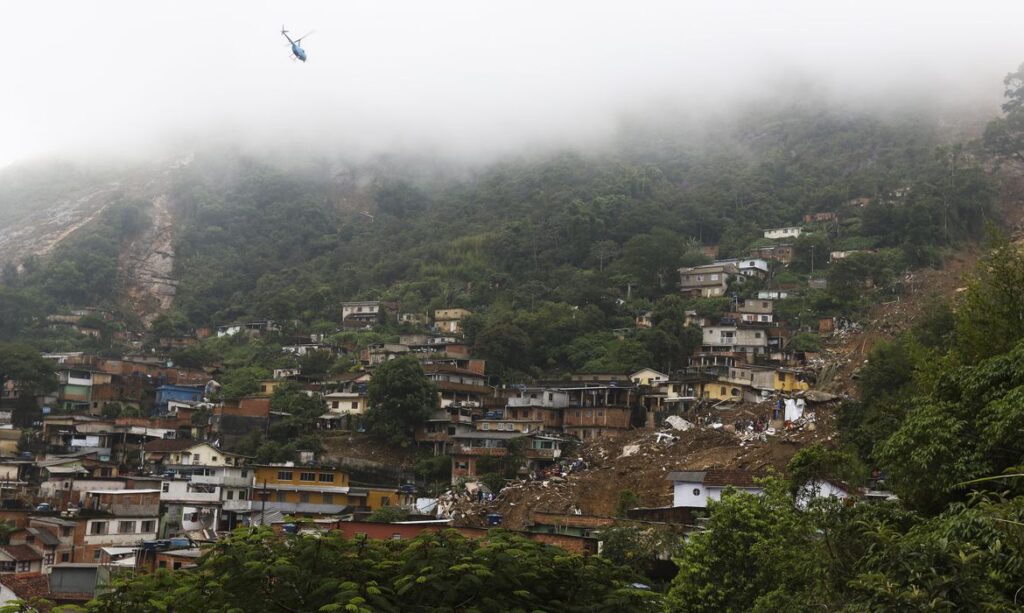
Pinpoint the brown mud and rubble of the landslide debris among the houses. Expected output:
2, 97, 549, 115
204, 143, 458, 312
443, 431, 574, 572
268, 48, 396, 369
442, 395, 840, 529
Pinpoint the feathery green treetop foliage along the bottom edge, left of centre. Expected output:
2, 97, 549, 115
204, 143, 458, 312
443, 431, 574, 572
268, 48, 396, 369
89, 529, 658, 613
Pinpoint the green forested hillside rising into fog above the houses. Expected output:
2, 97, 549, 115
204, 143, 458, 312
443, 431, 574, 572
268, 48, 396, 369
0, 97, 993, 377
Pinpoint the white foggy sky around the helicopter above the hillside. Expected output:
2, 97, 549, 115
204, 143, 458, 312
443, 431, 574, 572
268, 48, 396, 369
0, 0, 1024, 166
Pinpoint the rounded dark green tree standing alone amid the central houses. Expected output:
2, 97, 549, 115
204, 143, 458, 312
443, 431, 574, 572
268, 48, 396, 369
367, 356, 438, 445
